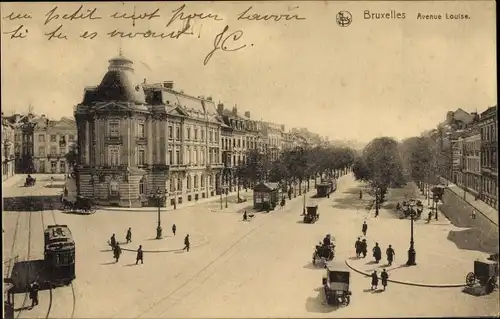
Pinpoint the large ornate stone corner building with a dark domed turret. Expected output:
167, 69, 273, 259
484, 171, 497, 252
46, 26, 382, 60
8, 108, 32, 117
74, 54, 225, 207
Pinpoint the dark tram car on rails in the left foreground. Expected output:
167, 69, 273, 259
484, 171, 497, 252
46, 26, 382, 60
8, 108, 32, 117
44, 225, 76, 285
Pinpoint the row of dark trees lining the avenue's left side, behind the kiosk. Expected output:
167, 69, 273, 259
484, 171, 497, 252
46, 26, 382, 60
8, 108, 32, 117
236, 146, 356, 195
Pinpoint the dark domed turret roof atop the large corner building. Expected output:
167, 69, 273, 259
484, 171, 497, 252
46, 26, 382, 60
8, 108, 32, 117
95, 54, 146, 104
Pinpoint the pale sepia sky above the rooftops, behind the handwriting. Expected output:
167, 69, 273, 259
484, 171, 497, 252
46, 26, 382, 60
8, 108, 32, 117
1, 1, 497, 142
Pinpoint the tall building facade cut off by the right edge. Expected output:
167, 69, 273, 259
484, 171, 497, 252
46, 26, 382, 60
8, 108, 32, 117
479, 106, 498, 208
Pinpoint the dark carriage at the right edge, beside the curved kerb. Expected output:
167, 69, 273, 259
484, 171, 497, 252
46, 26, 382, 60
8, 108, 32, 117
465, 255, 498, 294
